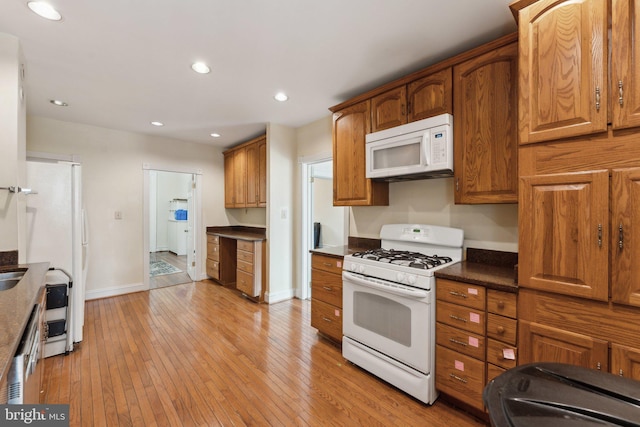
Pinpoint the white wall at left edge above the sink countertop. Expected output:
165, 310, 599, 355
0, 33, 26, 253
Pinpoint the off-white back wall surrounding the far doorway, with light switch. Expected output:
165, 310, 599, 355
27, 116, 229, 298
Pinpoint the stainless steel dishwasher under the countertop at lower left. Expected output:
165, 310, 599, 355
7, 304, 44, 404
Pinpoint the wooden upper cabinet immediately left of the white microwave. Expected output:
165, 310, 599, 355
333, 100, 389, 206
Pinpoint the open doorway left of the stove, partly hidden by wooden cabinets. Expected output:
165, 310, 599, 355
296, 155, 349, 299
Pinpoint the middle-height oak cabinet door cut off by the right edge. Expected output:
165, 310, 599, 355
611, 168, 640, 307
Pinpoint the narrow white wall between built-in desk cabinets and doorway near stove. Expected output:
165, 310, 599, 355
265, 124, 298, 303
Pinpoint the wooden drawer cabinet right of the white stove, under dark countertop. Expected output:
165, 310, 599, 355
436, 278, 518, 411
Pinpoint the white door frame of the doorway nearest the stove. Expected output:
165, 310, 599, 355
295, 153, 349, 300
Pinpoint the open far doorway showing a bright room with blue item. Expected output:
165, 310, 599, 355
144, 166, 202, 289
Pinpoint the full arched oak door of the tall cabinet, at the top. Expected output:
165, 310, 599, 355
518, 0, 608, 144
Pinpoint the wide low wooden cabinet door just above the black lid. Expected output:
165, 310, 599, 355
518, 320, 609, 372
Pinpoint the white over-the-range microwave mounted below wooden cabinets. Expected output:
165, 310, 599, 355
365, 114, 453, 181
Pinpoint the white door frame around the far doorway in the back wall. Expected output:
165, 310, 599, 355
142, 163, 205, 289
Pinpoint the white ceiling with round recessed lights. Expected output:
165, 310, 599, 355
0, 0, 516, 147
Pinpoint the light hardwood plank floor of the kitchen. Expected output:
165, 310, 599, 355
44, 281, 484, 427
